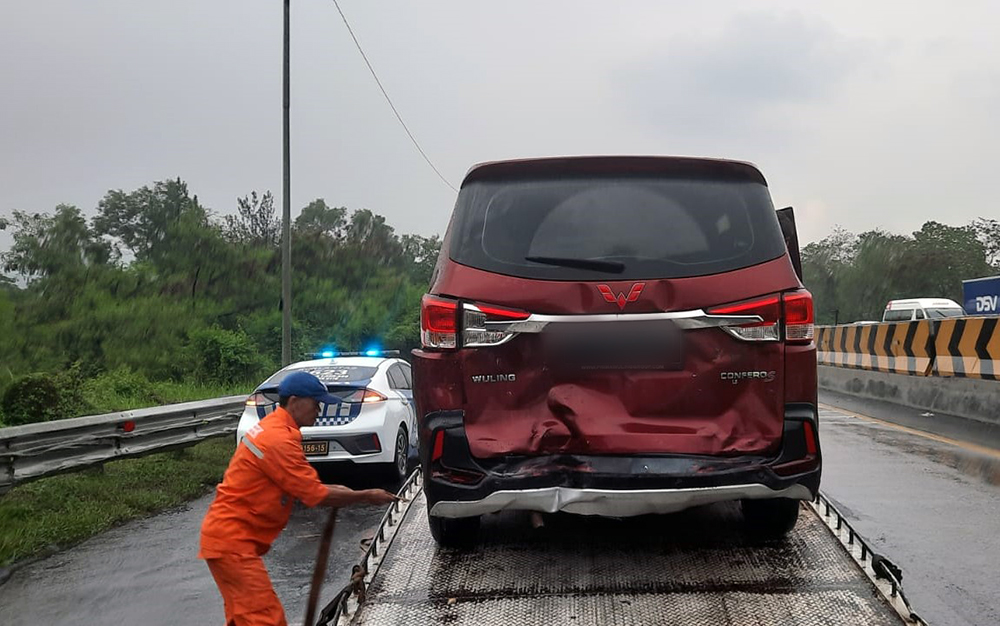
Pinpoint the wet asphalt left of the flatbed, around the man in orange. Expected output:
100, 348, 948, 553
0, 470, 395, 626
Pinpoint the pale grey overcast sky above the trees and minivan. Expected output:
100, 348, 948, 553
0, 0, 1000, 249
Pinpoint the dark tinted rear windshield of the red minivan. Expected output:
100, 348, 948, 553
449, 176, 785, 280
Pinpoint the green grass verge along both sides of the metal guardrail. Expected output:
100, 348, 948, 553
0, 383, 245, 567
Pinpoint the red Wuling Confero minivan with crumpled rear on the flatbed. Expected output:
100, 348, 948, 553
413, 156, 820, 546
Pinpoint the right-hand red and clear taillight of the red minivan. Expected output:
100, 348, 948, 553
708, 289, 816, 343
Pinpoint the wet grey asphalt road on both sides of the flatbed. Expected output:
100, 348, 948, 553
0, 398, 1000, 626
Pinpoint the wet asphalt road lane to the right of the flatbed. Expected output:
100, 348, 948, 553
820, 397, 1000, 626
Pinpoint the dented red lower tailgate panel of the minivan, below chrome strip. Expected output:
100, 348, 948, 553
459, 316, 783, 457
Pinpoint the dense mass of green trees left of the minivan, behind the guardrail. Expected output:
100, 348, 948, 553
0, 180, 440, 402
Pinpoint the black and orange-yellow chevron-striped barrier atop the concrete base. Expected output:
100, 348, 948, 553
816, 317, 1000, 380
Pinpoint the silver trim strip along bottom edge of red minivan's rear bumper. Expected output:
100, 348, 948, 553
430, 483, 812, 517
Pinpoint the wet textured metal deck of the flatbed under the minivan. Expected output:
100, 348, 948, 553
341, 482, 906, 626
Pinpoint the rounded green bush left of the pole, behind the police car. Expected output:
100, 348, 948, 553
189, 328, 265, 385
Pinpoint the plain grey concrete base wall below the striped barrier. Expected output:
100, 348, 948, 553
818, 365, 1000, 426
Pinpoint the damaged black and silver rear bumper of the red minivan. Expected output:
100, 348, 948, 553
421, 405, 821, 517
